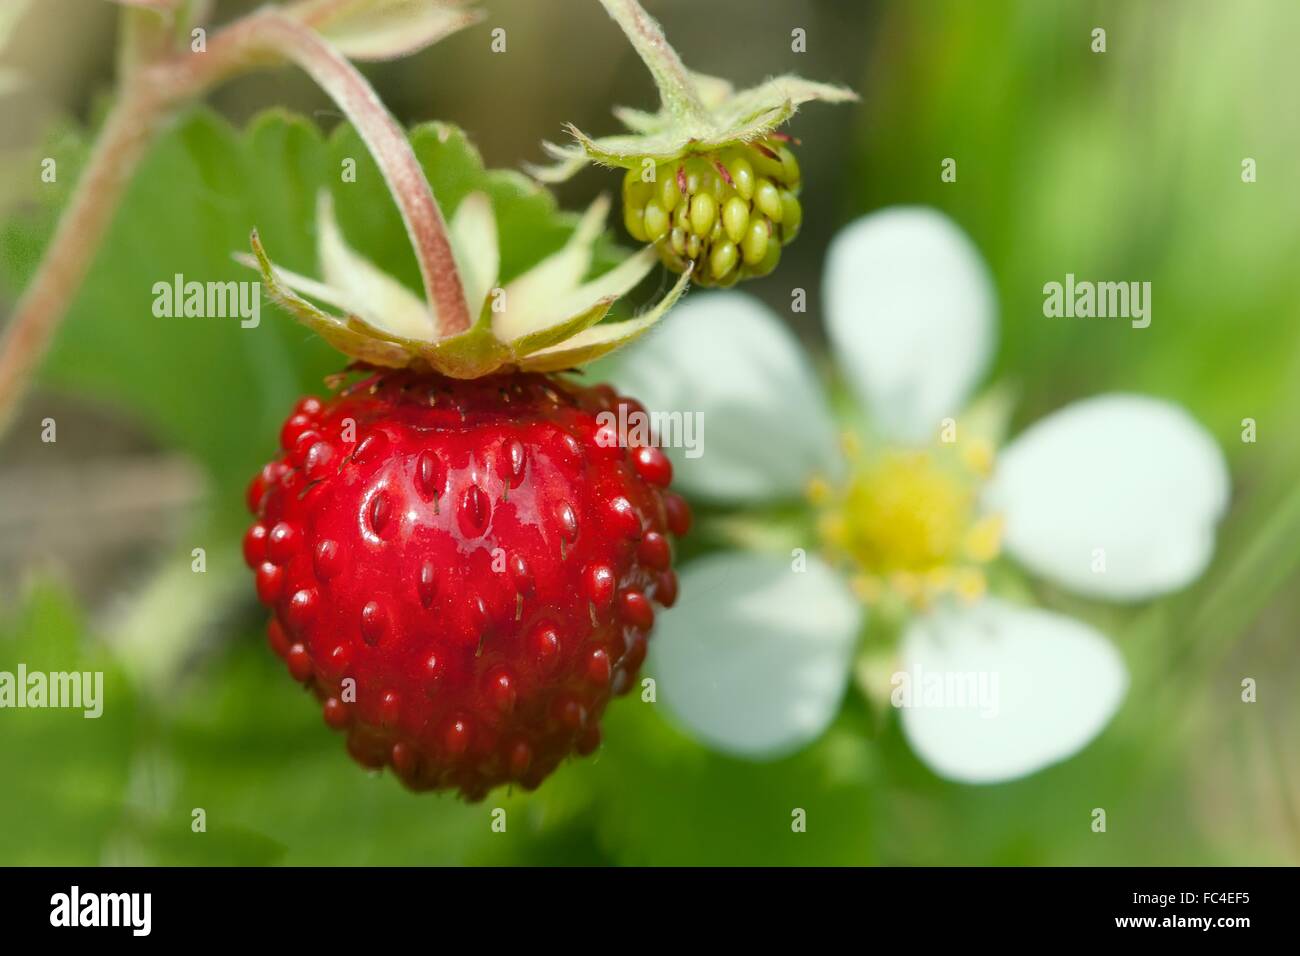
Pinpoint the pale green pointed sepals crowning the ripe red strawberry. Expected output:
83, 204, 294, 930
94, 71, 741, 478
237, 167, 688, 378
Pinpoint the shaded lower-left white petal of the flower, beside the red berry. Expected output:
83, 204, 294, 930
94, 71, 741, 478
650, 551, 862, 757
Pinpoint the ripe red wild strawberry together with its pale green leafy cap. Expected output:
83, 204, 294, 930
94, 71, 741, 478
243, 113, 690, 799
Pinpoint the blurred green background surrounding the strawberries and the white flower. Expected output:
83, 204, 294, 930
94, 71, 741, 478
0, 0, 1300, 865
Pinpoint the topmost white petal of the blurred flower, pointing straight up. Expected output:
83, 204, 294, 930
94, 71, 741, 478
826, 207, 997, 441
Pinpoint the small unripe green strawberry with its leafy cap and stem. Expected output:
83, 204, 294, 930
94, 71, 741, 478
529, 0, 858, 286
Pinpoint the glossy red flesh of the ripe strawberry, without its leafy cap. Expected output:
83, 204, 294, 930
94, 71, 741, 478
244, 371, 690, 799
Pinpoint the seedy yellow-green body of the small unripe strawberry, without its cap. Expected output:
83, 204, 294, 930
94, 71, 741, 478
623, 133, 803, 286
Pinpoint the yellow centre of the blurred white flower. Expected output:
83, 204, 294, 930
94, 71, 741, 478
809, 442, 1002, 606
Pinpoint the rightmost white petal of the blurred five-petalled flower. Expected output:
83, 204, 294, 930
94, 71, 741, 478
985, 394, 1229, 601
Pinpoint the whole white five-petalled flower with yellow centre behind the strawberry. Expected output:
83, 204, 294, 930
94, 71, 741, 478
618, 208, 1229, 783
